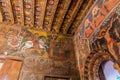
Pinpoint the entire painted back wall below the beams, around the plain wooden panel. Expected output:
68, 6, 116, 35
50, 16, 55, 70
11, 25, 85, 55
0, 23, 77, 80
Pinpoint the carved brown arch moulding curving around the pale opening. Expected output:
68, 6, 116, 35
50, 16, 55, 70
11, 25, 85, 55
84, 50, 113, 80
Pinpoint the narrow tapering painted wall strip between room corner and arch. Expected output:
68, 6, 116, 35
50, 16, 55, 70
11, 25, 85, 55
74, 36, 91, 80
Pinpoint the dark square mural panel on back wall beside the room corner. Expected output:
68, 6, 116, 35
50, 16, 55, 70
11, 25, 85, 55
49, 36, 75, 59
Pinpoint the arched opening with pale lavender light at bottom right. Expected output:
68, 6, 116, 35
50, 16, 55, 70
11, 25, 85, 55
98, 60, 120, 80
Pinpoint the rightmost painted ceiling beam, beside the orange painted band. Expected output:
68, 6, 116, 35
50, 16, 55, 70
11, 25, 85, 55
68, 0, 95, 35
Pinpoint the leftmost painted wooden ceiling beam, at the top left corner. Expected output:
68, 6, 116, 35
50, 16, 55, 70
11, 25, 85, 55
0, 0, 14, 24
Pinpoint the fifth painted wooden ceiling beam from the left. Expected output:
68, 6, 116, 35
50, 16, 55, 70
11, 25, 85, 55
43, 0, 59, 31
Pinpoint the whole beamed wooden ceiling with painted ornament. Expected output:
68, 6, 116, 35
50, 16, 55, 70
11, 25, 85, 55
0, 0, 95, 35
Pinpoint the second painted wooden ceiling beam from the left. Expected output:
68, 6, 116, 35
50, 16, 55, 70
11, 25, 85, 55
11, 0, 24, 26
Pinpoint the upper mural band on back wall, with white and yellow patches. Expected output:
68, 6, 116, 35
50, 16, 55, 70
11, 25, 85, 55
0, 24, 74, 59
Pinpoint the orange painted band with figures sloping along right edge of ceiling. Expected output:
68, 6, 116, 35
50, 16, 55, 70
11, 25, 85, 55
79, 0, 119, 38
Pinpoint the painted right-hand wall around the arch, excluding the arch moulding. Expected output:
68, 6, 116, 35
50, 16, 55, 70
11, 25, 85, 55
74, 0, 120, 80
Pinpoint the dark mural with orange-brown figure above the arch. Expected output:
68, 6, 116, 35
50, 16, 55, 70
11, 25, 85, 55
92, 13, 120, 65
